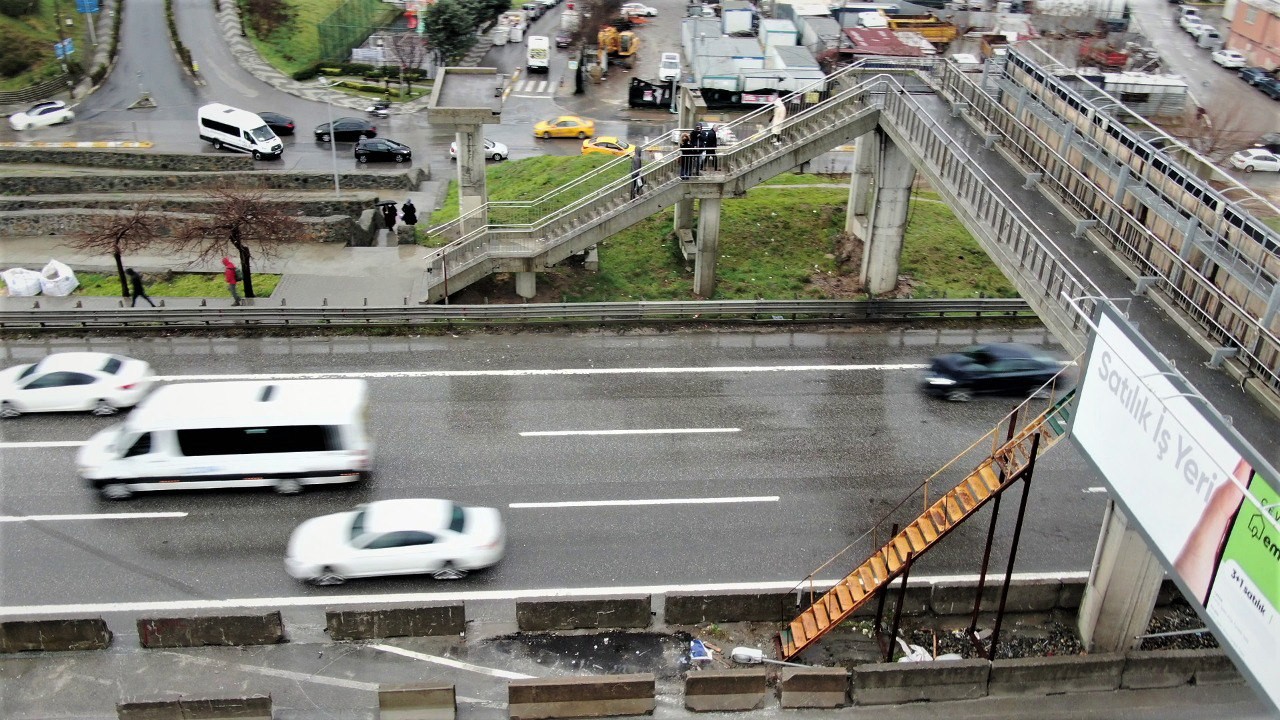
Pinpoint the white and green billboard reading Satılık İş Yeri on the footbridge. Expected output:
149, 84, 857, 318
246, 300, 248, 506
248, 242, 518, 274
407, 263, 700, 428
1071, 305, 1280, 707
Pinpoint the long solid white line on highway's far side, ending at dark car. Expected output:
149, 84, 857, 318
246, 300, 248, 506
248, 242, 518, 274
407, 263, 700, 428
155, 363, 928, 383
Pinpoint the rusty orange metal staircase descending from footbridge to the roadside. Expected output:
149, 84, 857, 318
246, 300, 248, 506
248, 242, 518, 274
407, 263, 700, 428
776, 391, 1074, 660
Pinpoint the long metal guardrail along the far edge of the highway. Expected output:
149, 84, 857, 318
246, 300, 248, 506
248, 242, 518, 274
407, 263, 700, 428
0, 299, 1036, 332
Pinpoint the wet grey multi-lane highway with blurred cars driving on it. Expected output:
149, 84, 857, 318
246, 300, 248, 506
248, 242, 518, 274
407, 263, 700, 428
0, 331, 1106, 612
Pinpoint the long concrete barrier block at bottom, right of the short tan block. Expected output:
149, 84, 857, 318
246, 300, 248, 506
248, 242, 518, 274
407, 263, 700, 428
507, 673, 657, 720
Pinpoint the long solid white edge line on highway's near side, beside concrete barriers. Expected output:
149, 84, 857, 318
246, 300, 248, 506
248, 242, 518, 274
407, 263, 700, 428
0, 570, 1089, 618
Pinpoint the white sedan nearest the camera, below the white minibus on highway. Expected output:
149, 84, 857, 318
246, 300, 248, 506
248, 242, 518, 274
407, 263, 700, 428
284, 498, 507, 585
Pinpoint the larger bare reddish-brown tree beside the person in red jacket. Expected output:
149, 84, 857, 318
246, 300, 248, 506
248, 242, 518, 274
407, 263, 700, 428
177, 187, 311, 297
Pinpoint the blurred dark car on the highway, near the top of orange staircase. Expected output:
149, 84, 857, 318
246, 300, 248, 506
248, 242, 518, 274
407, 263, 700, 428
924, 342, 1064, 402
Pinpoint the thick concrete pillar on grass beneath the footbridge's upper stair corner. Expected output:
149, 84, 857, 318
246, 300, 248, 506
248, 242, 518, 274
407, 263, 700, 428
859, 129, 915, 295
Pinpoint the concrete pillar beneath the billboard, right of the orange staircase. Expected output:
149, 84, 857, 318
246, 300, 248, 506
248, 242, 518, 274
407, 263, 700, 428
1076, 502, 1165, 652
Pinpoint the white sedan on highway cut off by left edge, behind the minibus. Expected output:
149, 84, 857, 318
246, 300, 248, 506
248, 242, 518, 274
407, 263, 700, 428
0, 352, 155, 418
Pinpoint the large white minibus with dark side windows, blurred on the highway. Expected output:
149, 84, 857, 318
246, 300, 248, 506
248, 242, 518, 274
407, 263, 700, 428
76, 379, 372, 500
